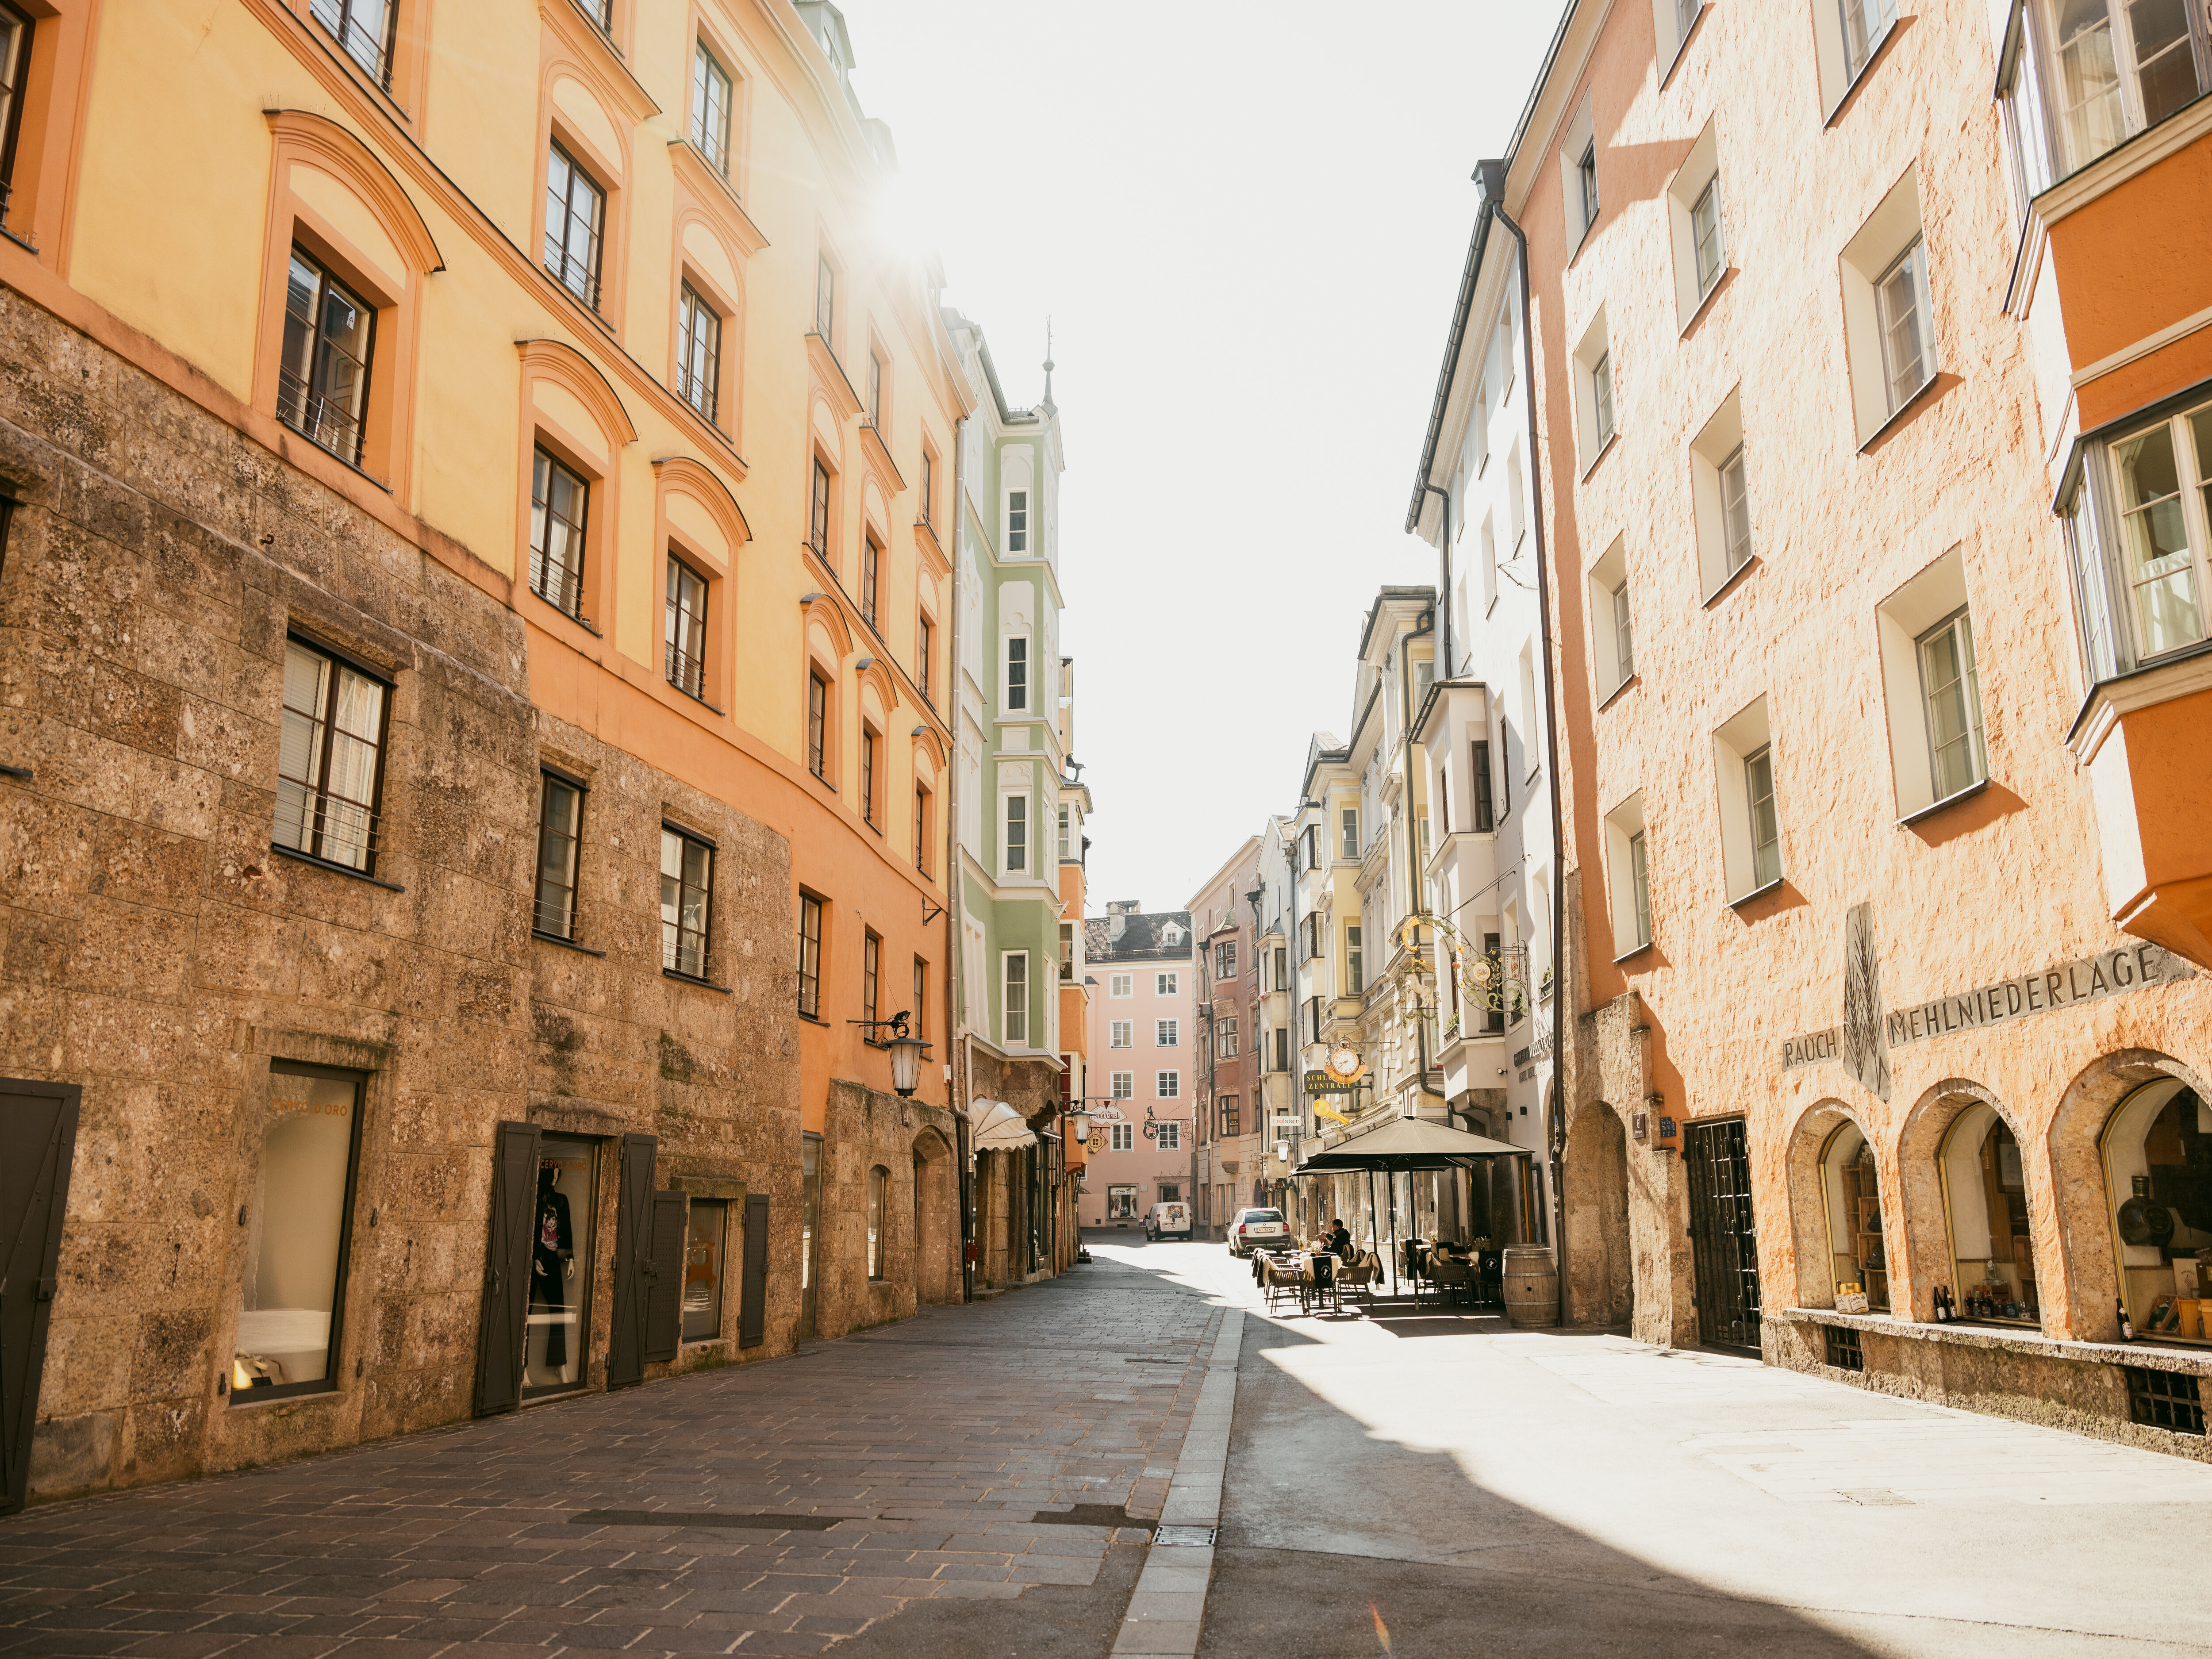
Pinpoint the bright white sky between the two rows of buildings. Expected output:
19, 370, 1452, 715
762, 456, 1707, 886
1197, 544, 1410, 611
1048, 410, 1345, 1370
838, 0, 1562, 914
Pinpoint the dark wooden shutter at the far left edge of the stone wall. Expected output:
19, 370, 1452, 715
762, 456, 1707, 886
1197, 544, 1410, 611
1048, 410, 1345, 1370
0, 1077, 84, 1515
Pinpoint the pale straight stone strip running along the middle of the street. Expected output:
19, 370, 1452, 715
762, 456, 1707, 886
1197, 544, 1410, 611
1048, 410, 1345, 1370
1113, 1307, 1243, 1659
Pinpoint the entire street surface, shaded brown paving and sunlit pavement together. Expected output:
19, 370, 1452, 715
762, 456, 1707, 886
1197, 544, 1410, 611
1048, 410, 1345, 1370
0, 1234, 2212, 1659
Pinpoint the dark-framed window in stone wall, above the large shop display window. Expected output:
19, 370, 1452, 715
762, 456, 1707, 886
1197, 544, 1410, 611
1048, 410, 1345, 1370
270, 639, 392, 874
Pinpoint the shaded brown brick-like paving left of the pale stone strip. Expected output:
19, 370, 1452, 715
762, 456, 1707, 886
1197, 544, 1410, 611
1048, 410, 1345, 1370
0, 1263, 1221, 1659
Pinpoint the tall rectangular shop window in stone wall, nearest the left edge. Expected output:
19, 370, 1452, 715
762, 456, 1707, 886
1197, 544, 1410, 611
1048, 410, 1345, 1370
230, 1064, 361, 1405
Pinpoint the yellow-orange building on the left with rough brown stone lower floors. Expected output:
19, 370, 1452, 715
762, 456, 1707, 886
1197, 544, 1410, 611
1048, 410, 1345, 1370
0, 0, 969, 1502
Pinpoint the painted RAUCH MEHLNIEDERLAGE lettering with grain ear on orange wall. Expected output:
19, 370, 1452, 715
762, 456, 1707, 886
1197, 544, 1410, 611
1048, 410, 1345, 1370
1781, 905, 2194, 1099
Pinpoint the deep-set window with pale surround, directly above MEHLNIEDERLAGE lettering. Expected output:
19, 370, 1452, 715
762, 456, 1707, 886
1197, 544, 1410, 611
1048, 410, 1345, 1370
1874, 546, 1989, 818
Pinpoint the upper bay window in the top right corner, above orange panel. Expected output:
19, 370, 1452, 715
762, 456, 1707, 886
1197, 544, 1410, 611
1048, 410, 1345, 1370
2039, 0, 2212, 173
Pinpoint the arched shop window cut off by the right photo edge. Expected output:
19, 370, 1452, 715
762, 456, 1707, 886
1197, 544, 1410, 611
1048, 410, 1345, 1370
2101, 1077, 2212, 1343
